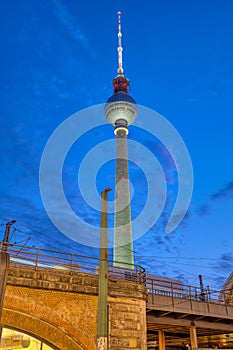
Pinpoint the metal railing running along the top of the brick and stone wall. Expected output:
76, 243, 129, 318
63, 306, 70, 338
0, 242, 146, 284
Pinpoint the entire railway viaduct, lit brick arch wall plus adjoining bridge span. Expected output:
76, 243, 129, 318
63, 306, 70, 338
1, 246, 233, 350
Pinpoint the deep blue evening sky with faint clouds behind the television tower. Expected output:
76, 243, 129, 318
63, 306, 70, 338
0, 0, 233, 289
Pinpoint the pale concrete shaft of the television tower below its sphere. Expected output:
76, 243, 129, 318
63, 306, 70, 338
114, 128, 134, 269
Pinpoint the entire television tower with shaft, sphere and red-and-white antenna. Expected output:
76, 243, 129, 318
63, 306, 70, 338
105, 12, 137, 268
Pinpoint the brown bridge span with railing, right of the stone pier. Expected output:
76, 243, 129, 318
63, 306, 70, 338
146, 278, 233, 345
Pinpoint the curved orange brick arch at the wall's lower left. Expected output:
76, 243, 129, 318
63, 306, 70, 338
1, 291, 95, 350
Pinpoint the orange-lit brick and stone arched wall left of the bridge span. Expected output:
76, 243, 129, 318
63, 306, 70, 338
1, 265, 146, 350
